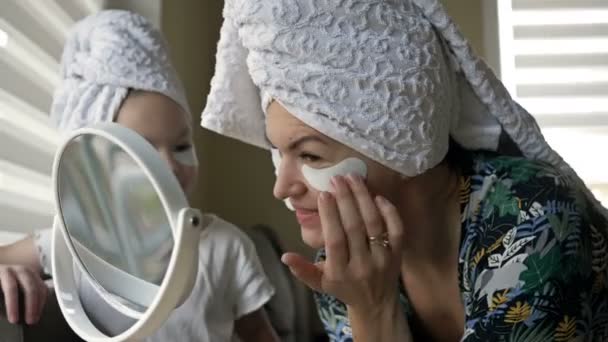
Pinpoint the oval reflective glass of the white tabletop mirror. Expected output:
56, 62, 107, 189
57, 134, 174, 316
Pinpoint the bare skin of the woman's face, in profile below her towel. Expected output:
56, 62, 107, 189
266, 101, 403, 248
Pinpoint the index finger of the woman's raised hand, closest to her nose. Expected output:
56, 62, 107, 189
318, 192, 348, 277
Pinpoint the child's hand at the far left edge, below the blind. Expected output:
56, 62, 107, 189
0, 265, 49, 324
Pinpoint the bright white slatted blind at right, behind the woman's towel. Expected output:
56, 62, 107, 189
492, 0, 608, 205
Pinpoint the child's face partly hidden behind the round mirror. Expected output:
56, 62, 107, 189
116, 91, 198, 195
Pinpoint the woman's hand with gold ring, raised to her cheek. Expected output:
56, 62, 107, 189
283, 175, 404, 312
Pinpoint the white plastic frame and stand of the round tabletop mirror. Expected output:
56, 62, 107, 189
52, 123, 208, 342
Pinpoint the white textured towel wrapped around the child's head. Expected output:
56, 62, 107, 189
51, 10, 190, 132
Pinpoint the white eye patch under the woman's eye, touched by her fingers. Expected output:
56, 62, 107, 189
302, 158, 367, 191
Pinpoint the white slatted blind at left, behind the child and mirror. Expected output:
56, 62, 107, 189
0, 0, 103, 244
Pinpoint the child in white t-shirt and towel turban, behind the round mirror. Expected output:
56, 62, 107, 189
0, 11, 277, 341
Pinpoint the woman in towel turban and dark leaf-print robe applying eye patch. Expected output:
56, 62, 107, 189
202, 0, 608, 341
